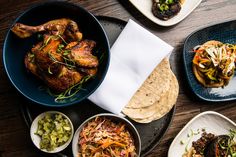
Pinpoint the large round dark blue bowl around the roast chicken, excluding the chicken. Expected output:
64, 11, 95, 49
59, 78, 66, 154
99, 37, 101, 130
3, 1, 110, 107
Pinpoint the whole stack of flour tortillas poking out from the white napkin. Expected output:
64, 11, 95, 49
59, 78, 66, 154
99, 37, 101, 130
122, 58, 179, 123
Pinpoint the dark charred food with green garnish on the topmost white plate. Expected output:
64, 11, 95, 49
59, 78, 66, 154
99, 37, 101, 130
152, 0, 183, 20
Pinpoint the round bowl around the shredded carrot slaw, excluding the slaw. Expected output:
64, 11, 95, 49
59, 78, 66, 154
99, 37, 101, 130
72, 113, 141, 157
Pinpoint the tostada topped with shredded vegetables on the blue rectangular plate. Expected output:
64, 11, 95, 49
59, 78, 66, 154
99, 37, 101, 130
193, 41, 236, 87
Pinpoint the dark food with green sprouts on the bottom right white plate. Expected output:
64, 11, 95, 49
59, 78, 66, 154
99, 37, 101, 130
182, 130, 236, 157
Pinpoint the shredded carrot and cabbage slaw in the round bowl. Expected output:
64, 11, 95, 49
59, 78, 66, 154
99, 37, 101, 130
78, 117, 137, 157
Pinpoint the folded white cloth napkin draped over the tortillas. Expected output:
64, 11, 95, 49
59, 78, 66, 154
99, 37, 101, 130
89, 19, 173, 114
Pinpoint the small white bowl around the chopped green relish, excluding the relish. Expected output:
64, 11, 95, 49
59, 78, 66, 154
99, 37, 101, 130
30, 111, 74, 153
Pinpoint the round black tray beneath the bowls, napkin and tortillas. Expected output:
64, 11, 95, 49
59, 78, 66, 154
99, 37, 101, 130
20, 16, 175, 156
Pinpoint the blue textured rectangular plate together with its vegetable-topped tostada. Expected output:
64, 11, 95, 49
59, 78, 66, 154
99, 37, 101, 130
183, 21, 236, 101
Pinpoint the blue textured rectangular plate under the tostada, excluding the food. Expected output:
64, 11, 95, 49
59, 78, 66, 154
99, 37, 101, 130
183, 21, 236, 101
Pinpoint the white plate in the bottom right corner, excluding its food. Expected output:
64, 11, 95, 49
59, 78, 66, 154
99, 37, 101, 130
168, 111, 236, 157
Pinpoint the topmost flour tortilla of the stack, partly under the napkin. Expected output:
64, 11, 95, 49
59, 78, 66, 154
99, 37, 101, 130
125, 58, 172, 109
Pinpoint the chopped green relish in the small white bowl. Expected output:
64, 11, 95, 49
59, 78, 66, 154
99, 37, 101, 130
35, 114, 72, 151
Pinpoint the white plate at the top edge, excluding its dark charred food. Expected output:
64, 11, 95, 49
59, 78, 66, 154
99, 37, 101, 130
129, 0, 202, 26
